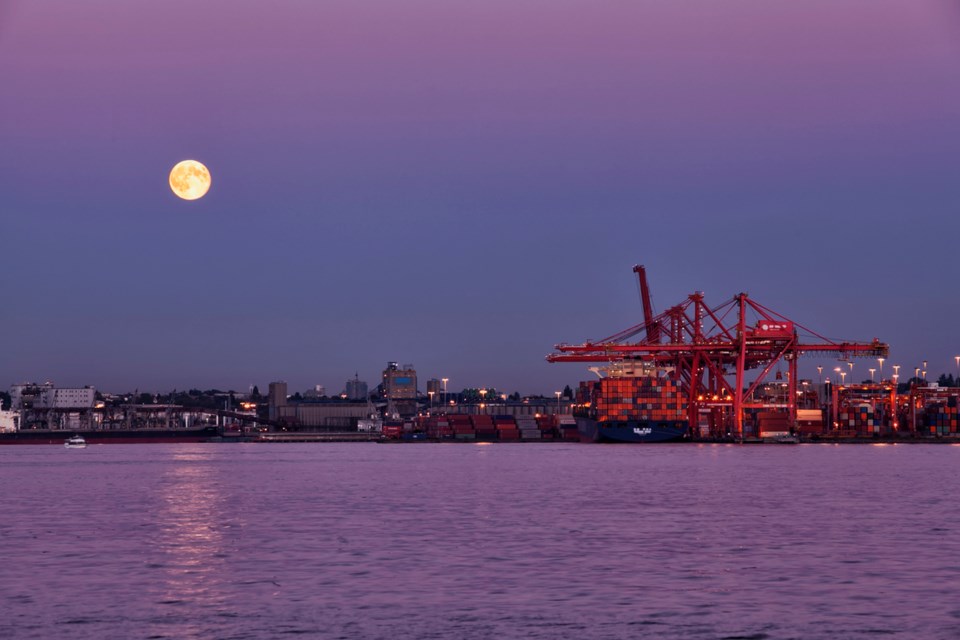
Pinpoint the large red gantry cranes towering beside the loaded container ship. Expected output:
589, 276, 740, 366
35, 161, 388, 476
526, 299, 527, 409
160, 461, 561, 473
547, 265, 889, 438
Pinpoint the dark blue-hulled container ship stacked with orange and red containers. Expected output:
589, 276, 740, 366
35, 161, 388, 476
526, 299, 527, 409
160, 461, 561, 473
574, 368, 690, 442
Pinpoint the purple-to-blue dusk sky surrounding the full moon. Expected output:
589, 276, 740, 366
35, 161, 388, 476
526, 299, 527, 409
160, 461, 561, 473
0, 0, 960, 393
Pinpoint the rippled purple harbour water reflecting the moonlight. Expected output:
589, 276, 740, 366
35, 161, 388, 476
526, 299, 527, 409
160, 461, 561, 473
0, 444, 960, 639
